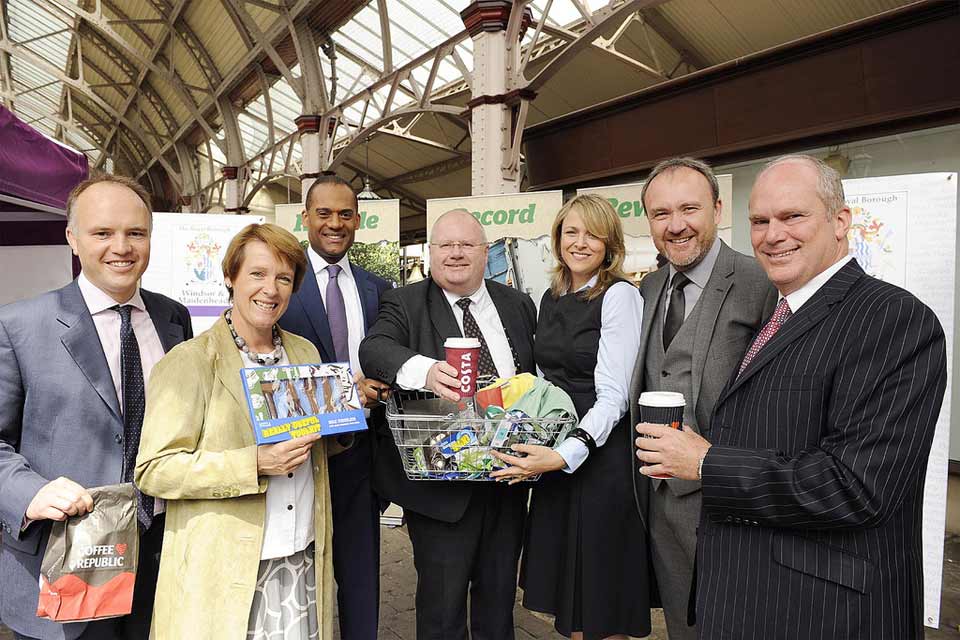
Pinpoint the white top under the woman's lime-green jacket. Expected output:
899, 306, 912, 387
249, 344, 314, 560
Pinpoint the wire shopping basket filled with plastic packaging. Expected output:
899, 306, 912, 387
387, 392, 575, 481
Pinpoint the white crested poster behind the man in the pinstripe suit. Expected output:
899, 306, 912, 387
843, 173, 957, 627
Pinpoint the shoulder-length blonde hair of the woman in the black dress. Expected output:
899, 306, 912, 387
550, 194, 627, 300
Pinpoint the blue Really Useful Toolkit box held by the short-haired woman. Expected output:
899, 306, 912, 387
240, 362, 367, 444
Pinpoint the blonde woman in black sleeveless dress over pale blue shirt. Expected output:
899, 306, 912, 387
494, 195, 651, 640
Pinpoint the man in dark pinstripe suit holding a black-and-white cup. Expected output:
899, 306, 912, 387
638, 156, 946, 640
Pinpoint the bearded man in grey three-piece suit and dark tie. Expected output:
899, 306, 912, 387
630, 158, 777, 640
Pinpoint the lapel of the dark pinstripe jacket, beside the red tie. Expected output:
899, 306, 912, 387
717, 260, 864, 406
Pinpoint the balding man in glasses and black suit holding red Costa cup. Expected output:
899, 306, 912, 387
360, 209, 537, 640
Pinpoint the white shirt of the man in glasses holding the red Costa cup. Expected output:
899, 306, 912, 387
397, 282, 517, 390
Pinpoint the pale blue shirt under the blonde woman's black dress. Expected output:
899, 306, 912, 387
554, 276, 643, 473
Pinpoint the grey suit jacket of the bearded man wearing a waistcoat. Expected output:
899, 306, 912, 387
629, 239, 778, 511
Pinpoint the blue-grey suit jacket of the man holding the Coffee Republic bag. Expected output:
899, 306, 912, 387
0, 281, 193, 639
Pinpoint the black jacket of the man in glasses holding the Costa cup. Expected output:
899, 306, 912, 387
360, 278, 537, 522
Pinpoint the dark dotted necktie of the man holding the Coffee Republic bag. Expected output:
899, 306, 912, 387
113, 305, 153, 531
